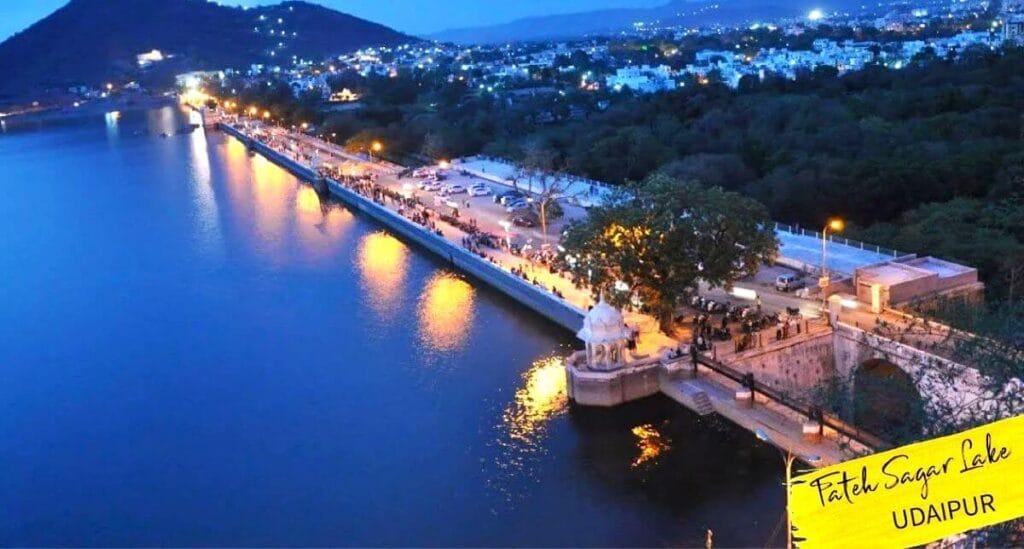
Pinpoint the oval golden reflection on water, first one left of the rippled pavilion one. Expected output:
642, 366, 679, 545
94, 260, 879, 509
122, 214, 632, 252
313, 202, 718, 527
419, 271, 475, 351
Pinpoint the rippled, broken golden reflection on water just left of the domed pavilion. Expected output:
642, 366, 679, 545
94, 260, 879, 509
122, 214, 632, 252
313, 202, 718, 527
503, 356, 568, 444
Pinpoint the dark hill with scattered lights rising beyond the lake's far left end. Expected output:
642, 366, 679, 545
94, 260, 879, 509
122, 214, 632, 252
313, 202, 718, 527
0, 0, 415, 98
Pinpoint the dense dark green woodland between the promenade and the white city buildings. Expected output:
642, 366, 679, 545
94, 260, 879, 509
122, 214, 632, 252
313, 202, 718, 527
540, 49, 1024, 296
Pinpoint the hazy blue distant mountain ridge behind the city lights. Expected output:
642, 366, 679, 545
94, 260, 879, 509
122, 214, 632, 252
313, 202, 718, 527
430, 0, 876, 44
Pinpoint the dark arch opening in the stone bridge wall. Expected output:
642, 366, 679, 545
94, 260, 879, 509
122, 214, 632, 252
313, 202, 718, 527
853, 358, 925, 445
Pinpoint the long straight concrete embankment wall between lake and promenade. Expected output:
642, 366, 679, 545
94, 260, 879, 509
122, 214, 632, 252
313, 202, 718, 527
219, 123, 585, 332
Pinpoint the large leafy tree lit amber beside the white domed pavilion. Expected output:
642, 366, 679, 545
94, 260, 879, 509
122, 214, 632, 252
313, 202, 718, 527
562, 174, 778, 334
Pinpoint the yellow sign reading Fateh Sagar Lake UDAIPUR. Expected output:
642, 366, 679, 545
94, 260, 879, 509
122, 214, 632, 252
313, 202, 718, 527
790, 416, 1024, 549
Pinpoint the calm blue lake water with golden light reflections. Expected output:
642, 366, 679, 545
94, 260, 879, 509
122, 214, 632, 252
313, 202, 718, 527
0, 109, 783, 546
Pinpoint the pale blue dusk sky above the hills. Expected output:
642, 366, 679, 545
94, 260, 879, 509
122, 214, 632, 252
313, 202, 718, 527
0, 0, 668, 40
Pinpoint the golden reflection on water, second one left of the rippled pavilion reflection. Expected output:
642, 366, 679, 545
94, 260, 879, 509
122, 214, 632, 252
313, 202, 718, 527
358, 233, 409, 319
